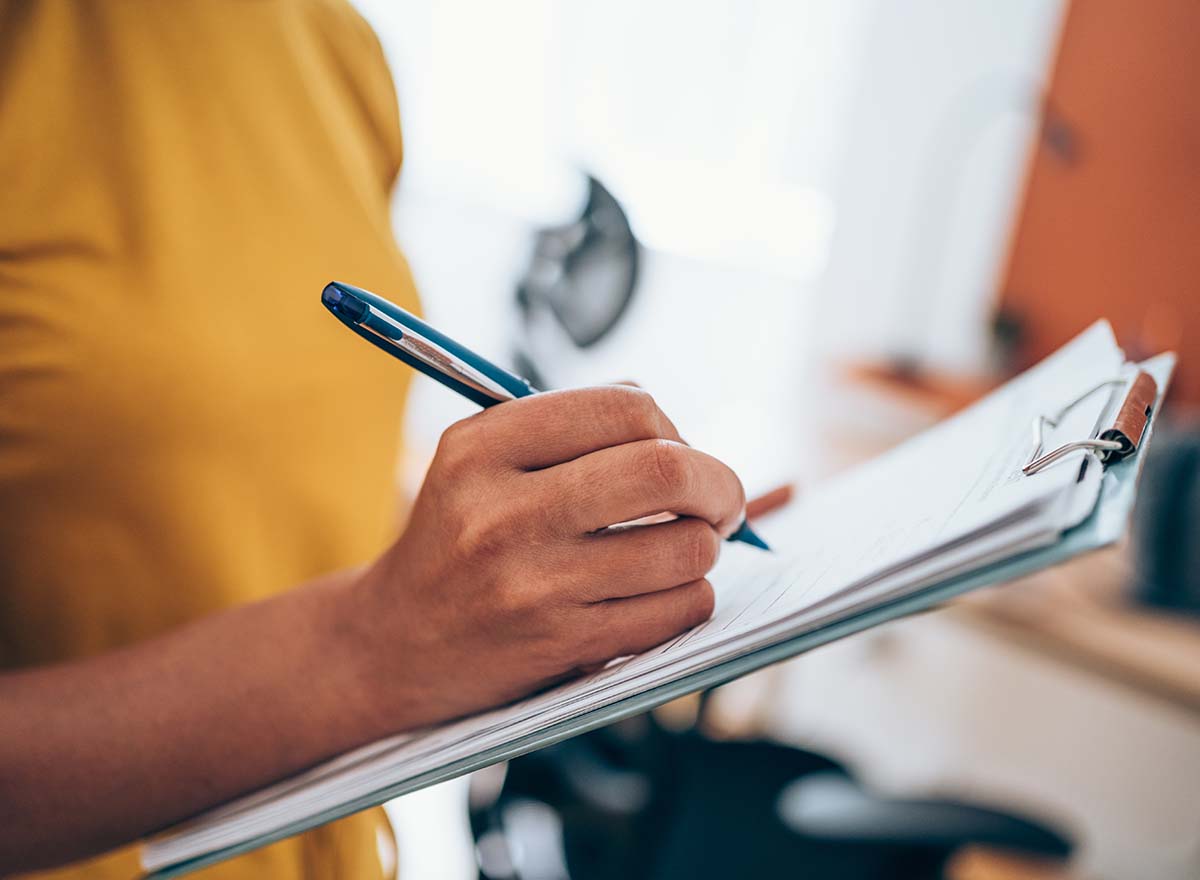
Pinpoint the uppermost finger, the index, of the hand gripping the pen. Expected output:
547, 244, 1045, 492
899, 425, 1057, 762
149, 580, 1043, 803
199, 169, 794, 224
472, 385, 683, 471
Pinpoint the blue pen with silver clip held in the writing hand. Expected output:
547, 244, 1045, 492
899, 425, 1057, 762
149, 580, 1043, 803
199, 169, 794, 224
320, 281, 770, 550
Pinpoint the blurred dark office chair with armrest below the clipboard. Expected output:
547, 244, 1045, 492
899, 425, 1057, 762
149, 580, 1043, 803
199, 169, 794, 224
470, 716, 1072, 880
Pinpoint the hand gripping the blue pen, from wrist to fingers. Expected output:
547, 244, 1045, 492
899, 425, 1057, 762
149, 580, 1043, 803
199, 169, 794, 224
343, 385, 745, 730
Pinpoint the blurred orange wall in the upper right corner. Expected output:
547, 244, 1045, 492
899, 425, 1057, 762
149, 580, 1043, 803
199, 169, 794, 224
1001, 0, 1200, 402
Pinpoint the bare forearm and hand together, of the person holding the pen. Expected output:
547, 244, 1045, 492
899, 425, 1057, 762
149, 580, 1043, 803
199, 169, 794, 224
0, 385, 786, 874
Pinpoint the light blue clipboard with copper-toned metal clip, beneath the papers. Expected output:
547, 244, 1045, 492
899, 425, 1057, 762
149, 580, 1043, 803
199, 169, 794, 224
143, 353, 1176, 880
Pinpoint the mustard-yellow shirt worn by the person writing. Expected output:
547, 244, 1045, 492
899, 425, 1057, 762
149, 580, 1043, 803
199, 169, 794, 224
0, 0, 415, 880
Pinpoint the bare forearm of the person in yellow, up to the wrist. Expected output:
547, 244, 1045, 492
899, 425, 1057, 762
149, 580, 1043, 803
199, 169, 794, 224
0, 575, 386, 874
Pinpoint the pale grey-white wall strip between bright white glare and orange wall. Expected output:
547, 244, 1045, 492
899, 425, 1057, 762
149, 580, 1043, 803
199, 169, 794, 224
821, 0, 1064, 369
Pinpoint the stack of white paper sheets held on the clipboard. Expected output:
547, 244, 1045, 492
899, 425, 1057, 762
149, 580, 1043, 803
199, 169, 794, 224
143, 323, 1161, 873
